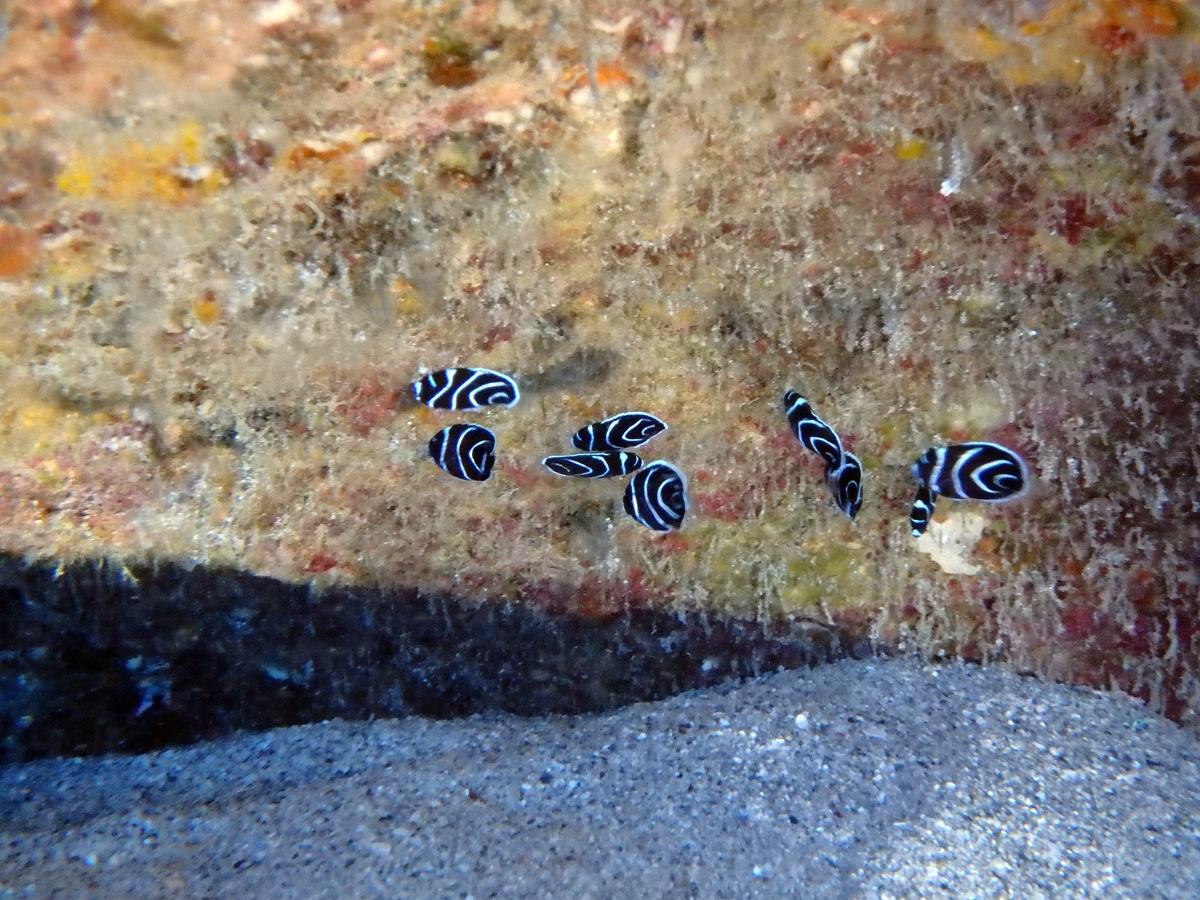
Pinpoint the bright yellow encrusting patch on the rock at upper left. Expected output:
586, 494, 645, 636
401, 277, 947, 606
56, 121, 226, 204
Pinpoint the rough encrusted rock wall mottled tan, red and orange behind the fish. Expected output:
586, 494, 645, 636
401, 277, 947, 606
0, 0, 1200, 724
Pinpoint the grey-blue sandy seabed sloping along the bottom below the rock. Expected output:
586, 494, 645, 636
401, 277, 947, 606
0, 660, 1200, 898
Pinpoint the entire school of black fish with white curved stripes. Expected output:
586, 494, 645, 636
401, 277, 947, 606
412, 367, 1030, 538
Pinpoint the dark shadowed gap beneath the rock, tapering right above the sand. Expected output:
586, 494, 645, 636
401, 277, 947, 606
0, 554, 877, 762
